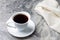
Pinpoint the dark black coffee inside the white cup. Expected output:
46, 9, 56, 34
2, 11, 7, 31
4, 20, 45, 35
13, 14, 28, 23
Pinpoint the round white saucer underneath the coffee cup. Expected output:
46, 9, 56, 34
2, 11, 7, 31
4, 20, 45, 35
7, 20, 35, 37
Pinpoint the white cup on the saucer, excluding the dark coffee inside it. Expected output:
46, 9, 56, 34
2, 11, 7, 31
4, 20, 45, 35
7, 12, 30, 30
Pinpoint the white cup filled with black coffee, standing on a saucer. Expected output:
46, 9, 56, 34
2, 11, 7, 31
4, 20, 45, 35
8, 12, 30, 30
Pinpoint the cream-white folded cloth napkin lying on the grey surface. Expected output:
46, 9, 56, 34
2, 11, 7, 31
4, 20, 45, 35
34, 0, 60, 33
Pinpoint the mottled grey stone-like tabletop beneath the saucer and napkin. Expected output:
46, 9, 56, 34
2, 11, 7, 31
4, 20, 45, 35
0, 0, 60, 40
